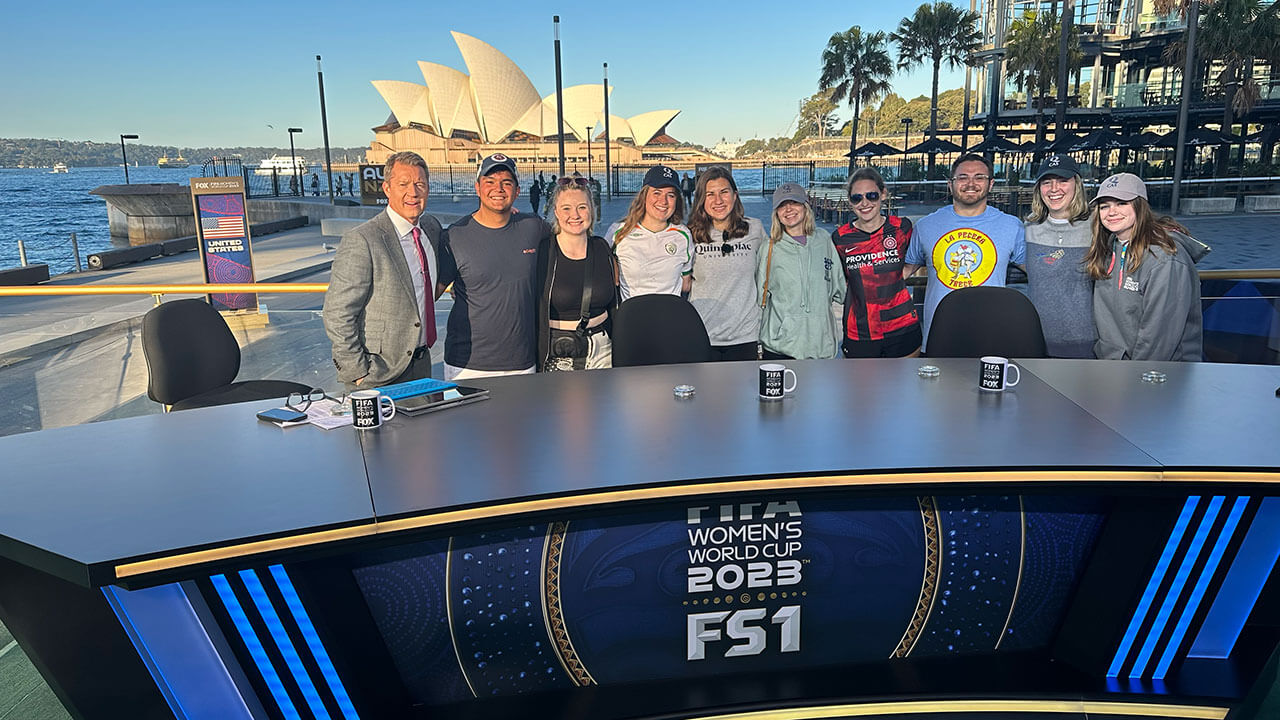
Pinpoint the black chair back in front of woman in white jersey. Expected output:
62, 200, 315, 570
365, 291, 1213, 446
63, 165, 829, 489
613, 295, 712, 368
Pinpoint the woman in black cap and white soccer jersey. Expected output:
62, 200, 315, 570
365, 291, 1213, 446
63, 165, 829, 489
604, 165, 694, 301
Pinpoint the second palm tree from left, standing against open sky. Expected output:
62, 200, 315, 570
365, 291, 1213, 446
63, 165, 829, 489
890, 0, 980, 144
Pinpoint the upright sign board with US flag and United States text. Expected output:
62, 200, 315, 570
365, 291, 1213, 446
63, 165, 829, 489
191, 177, 257, 310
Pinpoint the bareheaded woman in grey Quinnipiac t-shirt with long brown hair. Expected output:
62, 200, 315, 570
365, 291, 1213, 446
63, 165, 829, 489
689, 165, 767, 360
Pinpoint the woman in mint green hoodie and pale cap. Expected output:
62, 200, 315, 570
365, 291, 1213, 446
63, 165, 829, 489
755, 182, 845, 360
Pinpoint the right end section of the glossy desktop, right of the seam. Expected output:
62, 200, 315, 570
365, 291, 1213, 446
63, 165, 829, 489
1025, 360, 1280, 471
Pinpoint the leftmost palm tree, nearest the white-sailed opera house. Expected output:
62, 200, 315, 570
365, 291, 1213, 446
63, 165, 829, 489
818, 26, 890, 174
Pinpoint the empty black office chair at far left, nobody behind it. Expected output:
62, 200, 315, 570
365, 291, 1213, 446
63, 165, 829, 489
142, 300, 311, 410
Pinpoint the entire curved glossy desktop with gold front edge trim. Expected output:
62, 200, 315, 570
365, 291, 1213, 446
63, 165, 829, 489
0, 359, 1280, 584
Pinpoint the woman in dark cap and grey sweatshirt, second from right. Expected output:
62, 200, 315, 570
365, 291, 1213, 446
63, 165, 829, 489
1027, 155, 1098, 357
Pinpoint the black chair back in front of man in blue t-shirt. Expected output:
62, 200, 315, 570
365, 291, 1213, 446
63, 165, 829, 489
925, 287, 1048, 357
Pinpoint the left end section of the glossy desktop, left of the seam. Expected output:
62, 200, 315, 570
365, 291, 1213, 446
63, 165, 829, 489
0, 404, 374, 584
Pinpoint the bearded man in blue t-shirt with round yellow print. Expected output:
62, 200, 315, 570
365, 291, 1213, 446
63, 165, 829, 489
902, 154, 1027, 351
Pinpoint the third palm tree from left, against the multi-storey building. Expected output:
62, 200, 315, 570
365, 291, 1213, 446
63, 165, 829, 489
1005, 10, 1084, 155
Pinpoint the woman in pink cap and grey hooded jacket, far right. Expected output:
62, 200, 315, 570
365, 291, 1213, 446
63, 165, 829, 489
1084, 173, 1210, 361
